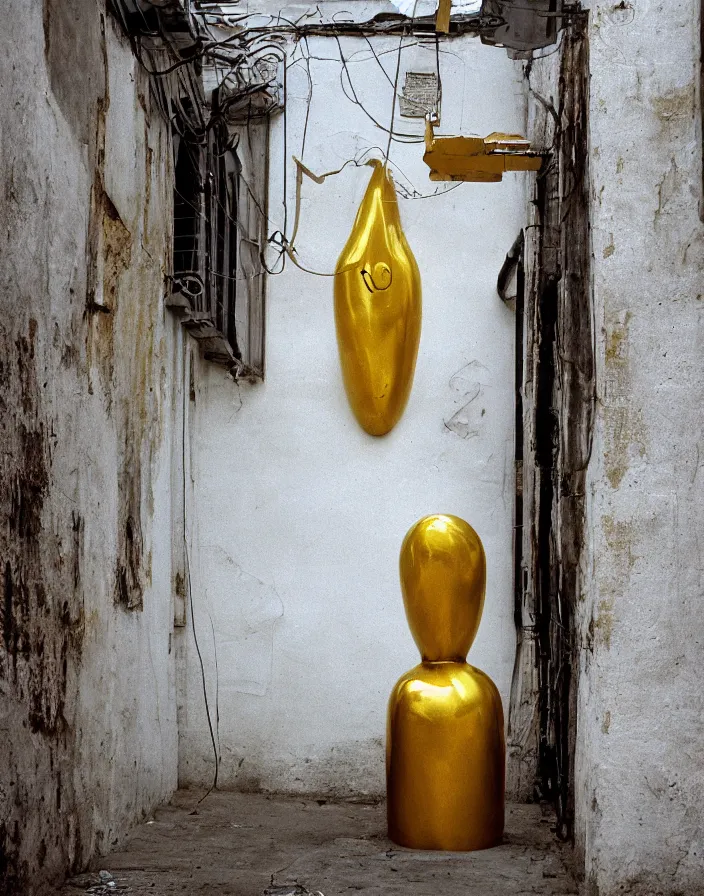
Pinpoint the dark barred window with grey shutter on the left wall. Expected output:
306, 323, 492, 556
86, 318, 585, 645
167, 120, 268, 380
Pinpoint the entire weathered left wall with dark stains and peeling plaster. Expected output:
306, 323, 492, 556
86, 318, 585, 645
0, 0, 178, 894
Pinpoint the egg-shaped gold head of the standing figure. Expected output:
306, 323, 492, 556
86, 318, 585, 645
400, 513, 486, 663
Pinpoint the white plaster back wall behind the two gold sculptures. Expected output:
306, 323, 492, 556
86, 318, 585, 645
179, 28, 524, 794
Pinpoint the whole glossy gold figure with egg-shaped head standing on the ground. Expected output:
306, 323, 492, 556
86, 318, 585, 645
386, 515, 505, 850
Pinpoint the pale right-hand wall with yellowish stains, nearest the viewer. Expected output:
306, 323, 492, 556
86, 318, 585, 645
576, 0, 704, 896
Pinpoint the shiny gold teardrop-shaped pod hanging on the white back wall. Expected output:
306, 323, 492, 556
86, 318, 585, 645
335, 162, 421, 436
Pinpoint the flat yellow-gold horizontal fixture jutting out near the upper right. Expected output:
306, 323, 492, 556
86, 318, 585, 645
423, 117, 543, 183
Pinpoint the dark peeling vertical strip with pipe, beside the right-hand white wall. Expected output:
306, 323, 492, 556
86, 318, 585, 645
508, 15, 595, 839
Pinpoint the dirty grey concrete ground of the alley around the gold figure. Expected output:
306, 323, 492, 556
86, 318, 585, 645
60, 791, 577, 896
